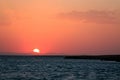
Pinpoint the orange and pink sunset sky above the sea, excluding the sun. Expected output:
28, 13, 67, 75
0, 0, 120, 55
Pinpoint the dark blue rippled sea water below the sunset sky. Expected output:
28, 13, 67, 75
0, 56, 120, 80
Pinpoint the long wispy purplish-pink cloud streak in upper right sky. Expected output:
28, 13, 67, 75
59, 10, 120, 24
